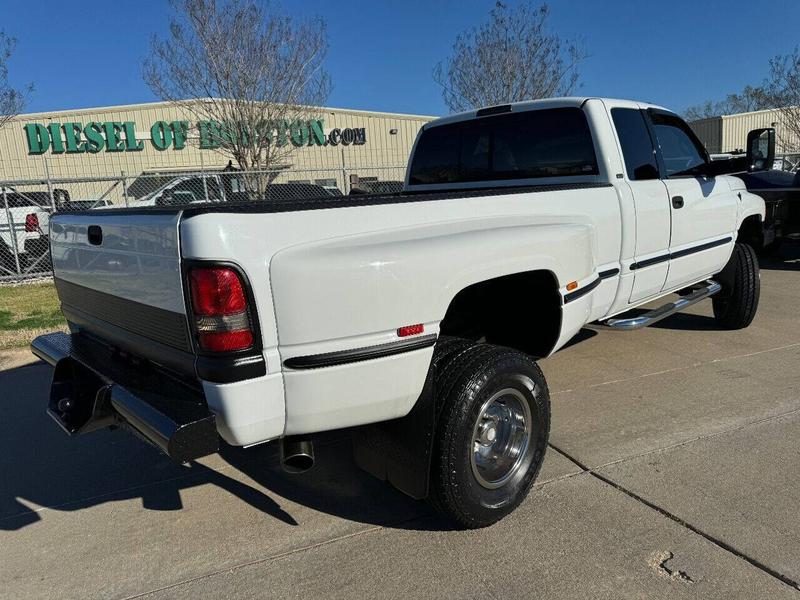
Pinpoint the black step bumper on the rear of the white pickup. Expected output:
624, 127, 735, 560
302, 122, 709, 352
31, 333, 219, 462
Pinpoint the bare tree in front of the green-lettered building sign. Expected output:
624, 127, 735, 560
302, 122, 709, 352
144, 0, 330, 197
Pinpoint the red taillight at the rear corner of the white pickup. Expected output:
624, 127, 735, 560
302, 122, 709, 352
189, 267, 253, 352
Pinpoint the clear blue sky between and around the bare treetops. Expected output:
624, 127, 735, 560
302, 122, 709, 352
0, 0, 800, 115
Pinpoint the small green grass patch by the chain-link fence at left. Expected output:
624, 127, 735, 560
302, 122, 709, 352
0, 282, 67, 350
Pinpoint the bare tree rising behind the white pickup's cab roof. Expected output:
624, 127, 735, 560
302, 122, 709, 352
433, 1, 588, 112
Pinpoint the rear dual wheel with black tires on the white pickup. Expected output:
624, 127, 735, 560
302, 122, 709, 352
429, 344, 550, 529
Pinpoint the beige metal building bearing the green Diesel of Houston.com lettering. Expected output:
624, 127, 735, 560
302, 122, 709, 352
0, 102, 434, 188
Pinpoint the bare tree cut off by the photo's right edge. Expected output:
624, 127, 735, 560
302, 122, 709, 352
766, 47, 800, 152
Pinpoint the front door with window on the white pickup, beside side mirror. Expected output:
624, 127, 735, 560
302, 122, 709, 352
648, 109, 739, 289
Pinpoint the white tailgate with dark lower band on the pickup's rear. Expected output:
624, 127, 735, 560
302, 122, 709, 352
50, 209, 192, 365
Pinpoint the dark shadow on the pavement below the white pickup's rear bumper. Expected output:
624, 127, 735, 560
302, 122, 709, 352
0, 363, 451, 531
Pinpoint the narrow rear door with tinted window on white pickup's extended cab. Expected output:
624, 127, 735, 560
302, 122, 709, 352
611, 108, 670, 302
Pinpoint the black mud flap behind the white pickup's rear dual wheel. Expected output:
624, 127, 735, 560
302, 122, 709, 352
353, 368, 436, 500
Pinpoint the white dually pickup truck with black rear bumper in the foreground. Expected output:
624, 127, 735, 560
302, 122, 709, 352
32, 98, 764, 527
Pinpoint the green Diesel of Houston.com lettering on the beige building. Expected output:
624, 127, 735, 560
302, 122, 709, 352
24, 119, 367, 154
